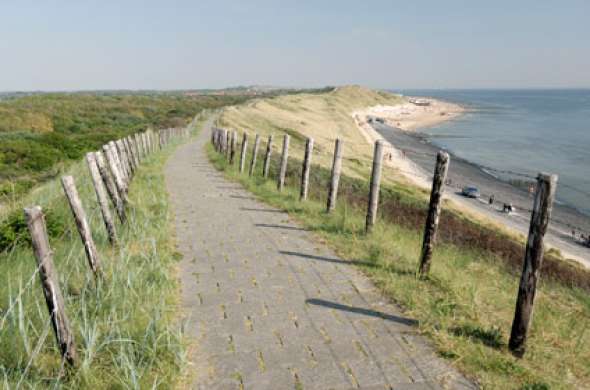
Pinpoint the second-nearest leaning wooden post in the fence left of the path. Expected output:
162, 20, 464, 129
61, 176, 101, 278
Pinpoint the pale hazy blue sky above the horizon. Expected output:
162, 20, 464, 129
0, 0, 590, 91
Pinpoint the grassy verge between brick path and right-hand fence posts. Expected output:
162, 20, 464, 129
208, 147, 590, 389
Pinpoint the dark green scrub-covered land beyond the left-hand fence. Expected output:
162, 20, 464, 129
0, 93, 246, 204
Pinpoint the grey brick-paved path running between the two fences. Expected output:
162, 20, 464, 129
166, 120, 473, 389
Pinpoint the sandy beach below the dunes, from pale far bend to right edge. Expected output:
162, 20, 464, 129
353, 99, 590, 268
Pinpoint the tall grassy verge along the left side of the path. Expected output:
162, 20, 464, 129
0, 122, 199, 389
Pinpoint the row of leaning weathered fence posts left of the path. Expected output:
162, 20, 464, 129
0, 127, 191, 378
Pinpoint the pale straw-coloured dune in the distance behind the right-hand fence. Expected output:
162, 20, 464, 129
219, 86, 404, 181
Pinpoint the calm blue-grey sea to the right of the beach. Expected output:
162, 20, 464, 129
397, 90, 590, 215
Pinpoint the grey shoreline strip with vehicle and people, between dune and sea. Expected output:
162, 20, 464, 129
373, 123, 590, 268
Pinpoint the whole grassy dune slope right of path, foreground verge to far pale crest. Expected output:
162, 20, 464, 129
211, 87, 590, 389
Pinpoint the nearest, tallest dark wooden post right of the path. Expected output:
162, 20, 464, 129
508, 173, 557, 357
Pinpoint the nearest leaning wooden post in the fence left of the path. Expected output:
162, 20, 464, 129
24, 206, 78, 366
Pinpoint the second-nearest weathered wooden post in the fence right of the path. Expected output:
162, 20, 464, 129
418, 151, 449, 277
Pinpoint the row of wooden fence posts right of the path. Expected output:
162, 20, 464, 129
211, 128, 568, 358
